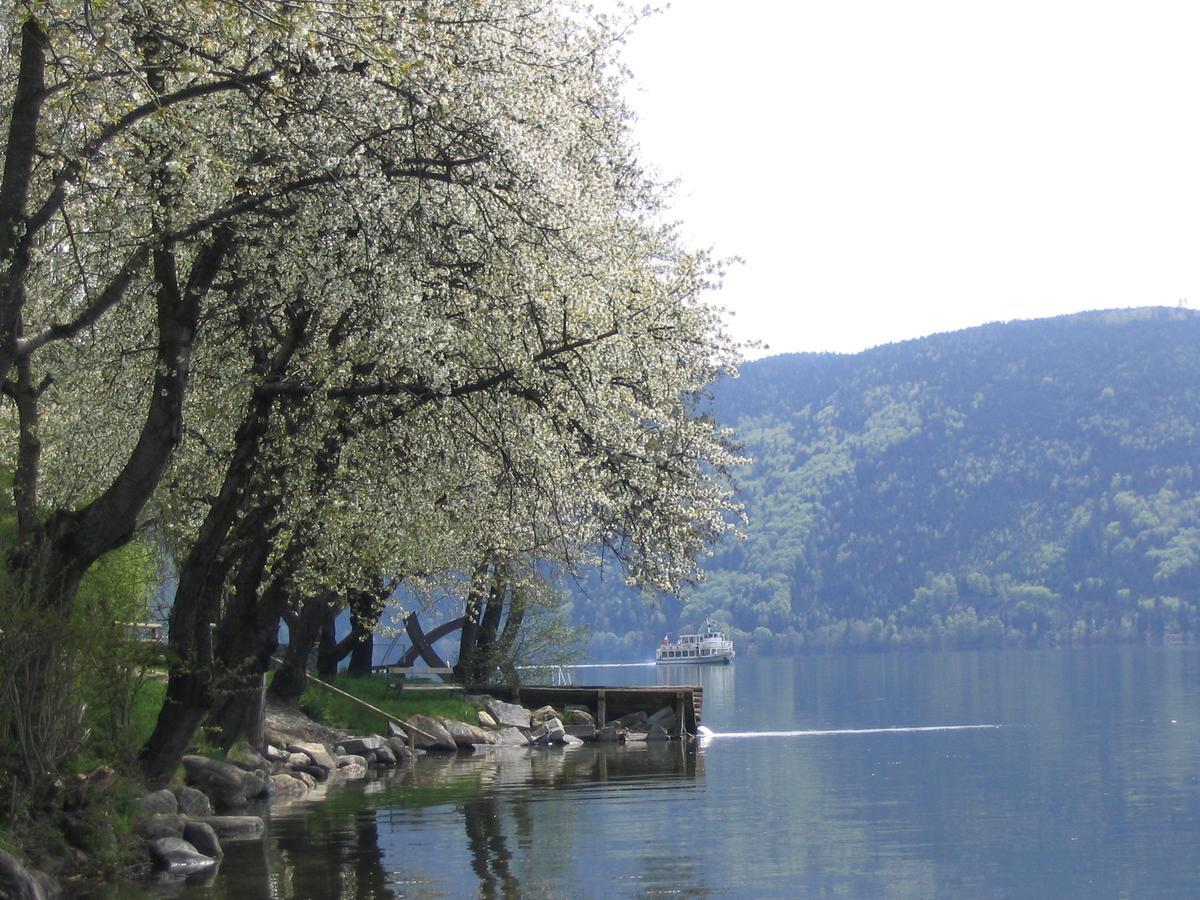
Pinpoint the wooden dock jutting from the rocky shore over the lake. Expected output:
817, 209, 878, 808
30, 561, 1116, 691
470, 684, 704, 737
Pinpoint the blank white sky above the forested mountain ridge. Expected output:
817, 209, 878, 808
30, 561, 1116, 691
596, 0, 1200, 356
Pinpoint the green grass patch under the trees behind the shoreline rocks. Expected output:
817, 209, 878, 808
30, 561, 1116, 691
300, 674, 478, 734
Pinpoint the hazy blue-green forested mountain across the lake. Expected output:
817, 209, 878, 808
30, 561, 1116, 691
572, 308, 1200, 658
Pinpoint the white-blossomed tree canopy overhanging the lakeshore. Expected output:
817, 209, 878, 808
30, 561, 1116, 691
0, 0, 736, 787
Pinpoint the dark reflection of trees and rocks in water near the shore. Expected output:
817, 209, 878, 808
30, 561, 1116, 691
131, 742, 703, 900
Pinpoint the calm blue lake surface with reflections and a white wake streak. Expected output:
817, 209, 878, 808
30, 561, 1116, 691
121, 647, 1200, 899
